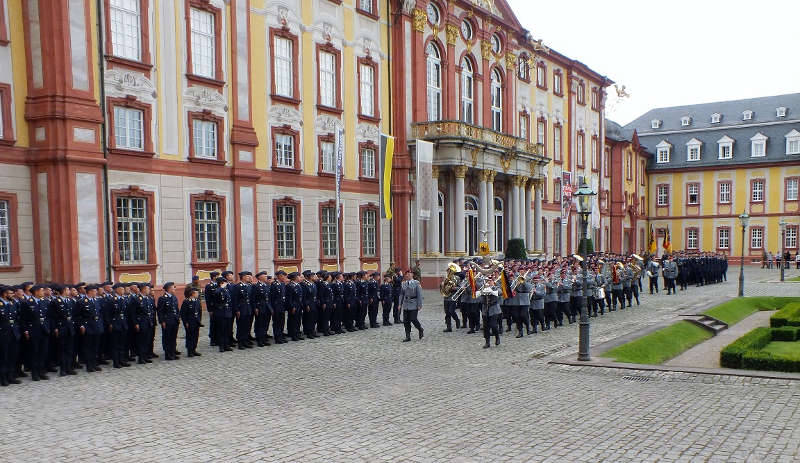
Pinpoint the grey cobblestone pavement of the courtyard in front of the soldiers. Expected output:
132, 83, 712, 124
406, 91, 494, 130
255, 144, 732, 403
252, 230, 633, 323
0, 269, 800, 463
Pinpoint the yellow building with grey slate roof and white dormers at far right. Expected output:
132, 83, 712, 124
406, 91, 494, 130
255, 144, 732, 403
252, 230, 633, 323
624, 94, 800, 263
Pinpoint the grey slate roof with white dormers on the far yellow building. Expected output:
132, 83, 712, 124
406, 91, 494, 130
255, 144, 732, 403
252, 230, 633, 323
624, 93, 800, 170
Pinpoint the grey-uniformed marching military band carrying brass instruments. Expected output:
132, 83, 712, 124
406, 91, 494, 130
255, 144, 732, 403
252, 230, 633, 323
440, 254, 642, 347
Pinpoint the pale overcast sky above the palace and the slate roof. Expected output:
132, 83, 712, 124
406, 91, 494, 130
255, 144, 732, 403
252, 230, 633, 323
508, 0, 800, 125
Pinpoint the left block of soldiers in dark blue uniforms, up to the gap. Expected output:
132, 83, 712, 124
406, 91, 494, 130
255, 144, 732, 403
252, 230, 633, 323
0, 281, 195, 386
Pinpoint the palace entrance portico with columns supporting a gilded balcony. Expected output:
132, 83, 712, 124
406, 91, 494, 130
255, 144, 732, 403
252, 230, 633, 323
409, 121, 550, 284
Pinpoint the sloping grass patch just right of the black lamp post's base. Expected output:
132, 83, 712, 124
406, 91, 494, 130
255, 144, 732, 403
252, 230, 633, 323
603, 320, 712, 365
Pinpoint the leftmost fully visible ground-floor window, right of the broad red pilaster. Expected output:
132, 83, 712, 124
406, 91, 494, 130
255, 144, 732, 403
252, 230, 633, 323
116, 197, 147, 264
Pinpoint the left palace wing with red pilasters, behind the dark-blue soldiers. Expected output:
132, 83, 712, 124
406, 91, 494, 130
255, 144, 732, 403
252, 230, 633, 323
0, 0, 391, 283
